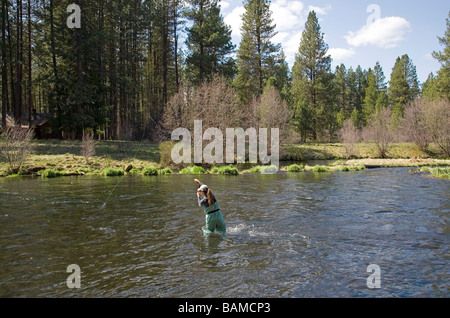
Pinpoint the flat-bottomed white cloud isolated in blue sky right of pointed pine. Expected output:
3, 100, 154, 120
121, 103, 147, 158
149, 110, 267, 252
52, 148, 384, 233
345, 17, 410, 48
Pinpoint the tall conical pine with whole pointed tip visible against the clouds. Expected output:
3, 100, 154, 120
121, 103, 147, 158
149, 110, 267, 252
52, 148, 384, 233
292, 11, 333, 139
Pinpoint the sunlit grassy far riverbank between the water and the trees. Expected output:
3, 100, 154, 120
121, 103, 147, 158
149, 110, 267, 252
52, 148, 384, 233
0, 140, 450, 178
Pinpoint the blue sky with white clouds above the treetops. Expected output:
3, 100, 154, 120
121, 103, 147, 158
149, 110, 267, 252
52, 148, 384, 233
220, 0, 450, 83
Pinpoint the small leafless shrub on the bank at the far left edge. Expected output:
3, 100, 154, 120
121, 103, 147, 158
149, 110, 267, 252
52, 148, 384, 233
0, 125, 34, 173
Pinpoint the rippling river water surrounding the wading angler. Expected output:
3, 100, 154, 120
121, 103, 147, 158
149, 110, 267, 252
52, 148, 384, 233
0, 168, 450, 297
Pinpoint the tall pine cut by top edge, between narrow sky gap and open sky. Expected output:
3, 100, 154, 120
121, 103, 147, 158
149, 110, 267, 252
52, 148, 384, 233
234, 0, 280, 104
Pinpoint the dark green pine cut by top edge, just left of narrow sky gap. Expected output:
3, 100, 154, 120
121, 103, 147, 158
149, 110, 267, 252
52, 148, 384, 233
185, 0, 235, 85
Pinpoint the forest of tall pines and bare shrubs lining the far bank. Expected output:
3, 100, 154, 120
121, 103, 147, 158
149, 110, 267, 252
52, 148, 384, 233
1, 0, 450, 156
